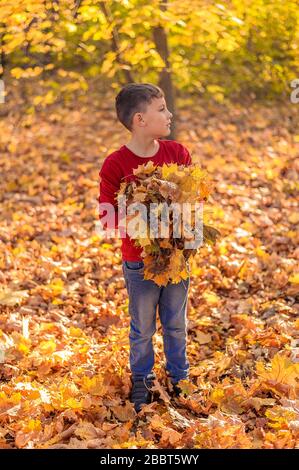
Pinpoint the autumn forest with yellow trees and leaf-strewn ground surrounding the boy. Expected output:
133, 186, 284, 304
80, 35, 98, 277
0, 0, 299, 449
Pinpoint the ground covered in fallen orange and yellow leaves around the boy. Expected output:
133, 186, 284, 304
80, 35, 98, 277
0, 92, 299, 448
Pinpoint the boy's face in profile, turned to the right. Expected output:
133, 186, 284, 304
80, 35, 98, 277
134, 98, 173, 139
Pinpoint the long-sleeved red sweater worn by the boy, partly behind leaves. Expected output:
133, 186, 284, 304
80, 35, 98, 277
98, 139, 192, 261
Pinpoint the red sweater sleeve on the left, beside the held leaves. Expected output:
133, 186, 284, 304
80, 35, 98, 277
98, 159, 122, 230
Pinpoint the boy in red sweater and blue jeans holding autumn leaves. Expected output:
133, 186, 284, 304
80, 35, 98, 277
98, 83, 191, 412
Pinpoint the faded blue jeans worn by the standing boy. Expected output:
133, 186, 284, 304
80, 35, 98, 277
122, 261, 190, 383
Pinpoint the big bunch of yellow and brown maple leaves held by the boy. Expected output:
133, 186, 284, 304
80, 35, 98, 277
118, 161, 219, 286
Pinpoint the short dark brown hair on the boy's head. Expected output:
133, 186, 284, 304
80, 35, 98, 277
115, 83, 164, 131
